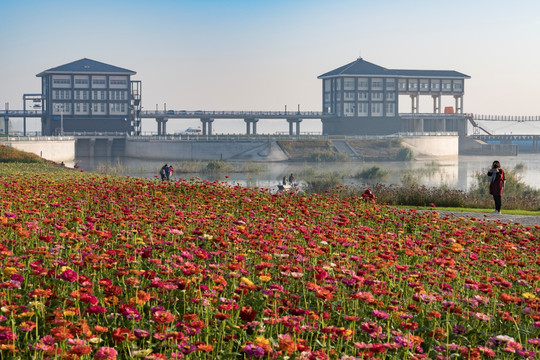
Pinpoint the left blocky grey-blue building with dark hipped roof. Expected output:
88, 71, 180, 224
36, 58, 141, 135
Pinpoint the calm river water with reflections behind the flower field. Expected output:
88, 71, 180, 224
66, 154, 540, 190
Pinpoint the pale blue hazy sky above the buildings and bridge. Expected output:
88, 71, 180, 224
0, 0, 540, 133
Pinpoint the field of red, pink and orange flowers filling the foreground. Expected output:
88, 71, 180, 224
0, 165, 540, 360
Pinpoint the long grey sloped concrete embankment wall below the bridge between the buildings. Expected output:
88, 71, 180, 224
125, 139, 288, 161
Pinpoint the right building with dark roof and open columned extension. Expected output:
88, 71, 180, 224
318, 58, 470, 135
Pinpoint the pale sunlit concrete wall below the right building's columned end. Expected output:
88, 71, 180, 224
402, 135, 459, 159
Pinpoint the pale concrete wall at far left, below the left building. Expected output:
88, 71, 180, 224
0, 138, 75, 162
